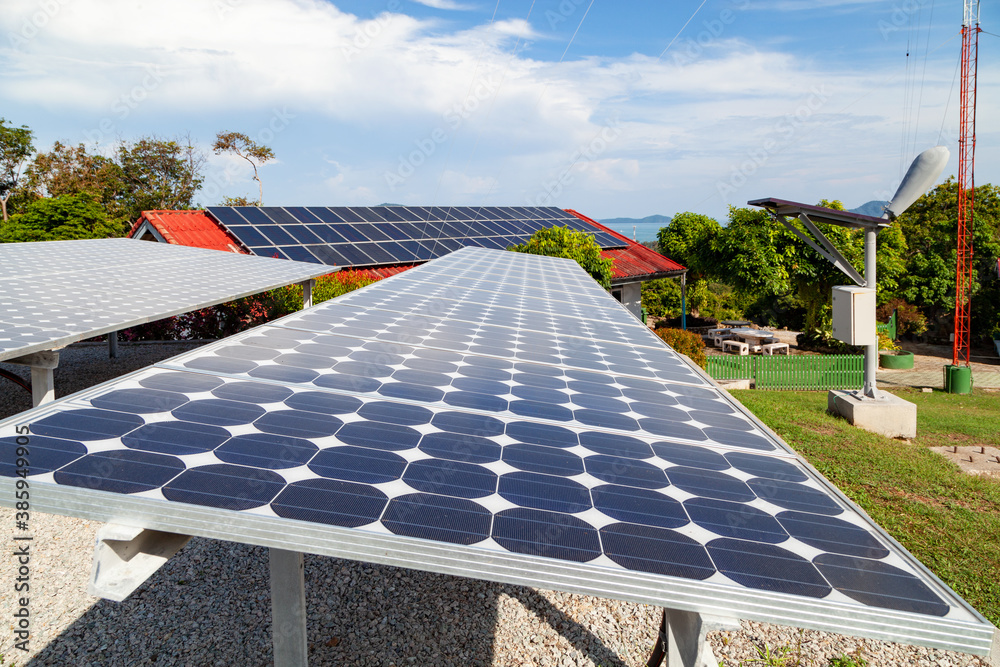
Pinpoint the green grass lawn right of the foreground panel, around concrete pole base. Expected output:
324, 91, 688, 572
732, 390, 1000, 625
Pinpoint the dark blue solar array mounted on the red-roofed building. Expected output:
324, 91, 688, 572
207, 206, 627, 267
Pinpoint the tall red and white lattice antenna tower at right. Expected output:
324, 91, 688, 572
952, 0, 981, 366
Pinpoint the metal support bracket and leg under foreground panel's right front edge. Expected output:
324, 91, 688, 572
646, 609, 740, 667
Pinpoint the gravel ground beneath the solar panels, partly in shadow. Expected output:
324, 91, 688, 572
0, 344, 988, 667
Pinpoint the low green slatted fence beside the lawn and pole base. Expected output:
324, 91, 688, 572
707, 354, 864, 390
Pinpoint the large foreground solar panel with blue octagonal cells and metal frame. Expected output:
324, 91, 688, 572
0, 248, 994, 654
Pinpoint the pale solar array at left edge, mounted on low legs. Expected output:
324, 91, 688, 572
0, 239, 328, 360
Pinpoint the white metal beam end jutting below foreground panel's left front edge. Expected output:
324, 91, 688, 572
87, 523, 191, 602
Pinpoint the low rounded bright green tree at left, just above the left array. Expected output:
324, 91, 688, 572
0, 193, 118, 243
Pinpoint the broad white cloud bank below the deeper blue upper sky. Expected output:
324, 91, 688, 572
0, 0, 984, 216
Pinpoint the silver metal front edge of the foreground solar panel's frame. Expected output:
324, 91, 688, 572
0, 478, 994, 655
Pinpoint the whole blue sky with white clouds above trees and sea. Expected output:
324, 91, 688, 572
0, 0, 1000, 219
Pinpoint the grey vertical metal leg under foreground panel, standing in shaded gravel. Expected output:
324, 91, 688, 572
270, 548, 309, 667
